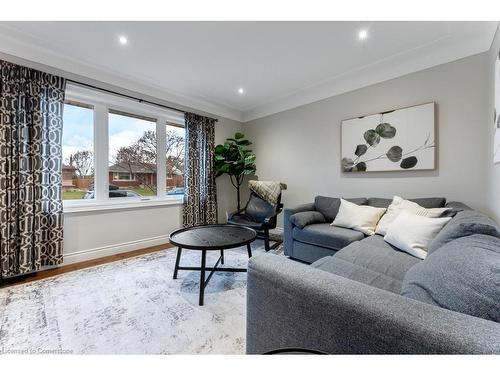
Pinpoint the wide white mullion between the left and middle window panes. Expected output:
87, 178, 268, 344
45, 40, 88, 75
94, 104, 109, 202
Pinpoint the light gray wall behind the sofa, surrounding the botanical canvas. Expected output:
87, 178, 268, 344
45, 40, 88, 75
244, 53, 490, 226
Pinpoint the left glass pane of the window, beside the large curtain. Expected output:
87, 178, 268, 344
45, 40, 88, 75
62, 102, 94, 200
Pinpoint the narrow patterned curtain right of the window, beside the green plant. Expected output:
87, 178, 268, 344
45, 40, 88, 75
183, 113, 217, 227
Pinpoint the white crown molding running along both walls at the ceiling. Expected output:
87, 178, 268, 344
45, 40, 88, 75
0, 22, 499, 123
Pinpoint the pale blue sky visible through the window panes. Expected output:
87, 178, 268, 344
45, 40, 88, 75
62, 104, 184, 164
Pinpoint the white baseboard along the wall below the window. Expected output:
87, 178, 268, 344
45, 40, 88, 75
63, 234, 169, 265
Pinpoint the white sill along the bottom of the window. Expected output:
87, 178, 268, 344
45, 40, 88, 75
63, 198, 183, 214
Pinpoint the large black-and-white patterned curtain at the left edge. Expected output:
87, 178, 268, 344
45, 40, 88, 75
0, 60, 66, 278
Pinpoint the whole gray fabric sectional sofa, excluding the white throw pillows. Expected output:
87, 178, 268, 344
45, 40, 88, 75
247, 197, 500, 354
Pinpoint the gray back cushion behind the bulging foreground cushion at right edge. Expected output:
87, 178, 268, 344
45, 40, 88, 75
427, 210, 500, 254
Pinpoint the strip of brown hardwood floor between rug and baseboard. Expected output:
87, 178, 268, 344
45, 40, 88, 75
0, 244, 174, 288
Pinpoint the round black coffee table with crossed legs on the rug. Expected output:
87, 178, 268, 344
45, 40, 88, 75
170, 224, 257, 306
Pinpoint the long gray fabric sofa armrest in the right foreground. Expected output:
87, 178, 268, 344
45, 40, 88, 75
246, 254, 500, 354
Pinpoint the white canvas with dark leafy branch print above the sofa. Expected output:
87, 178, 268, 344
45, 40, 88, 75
341, 103, 436, 172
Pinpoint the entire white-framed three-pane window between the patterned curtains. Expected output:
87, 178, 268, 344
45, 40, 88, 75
63, 85, 184, 210
